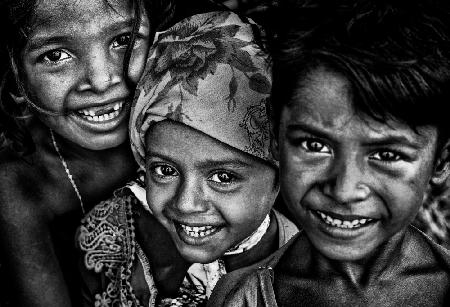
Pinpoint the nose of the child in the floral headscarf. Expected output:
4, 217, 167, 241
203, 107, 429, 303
173, 179, 208, 214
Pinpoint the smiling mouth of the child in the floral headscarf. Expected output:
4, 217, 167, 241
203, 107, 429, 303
173, 221, 223, 246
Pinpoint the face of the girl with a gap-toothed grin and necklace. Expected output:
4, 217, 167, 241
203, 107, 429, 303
21, 0, 149, 150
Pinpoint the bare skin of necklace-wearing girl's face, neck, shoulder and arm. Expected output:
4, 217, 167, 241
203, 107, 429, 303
0, 0, 148, 306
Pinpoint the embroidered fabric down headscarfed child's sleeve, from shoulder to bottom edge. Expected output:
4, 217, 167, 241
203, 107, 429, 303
78, 188, 142, 307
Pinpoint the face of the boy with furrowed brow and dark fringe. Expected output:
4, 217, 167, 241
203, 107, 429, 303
275, 68, 437, 261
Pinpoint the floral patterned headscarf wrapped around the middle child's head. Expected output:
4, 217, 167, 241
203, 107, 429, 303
130, 12, 276, 166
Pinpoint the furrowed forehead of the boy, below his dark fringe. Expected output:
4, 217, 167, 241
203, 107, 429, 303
282, 67, 437, 144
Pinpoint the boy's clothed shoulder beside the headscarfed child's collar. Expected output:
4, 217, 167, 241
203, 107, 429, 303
208, 234, 298, 306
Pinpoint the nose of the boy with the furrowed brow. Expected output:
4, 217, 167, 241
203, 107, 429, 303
324, 157, 370, 204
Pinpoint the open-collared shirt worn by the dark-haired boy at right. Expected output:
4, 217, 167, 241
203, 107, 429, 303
207, 226, 450, 307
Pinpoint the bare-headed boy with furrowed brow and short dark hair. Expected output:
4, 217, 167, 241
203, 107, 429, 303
210, 0, 450, 307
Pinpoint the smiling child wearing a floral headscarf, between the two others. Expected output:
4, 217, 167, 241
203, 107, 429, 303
78, 12, 297, 306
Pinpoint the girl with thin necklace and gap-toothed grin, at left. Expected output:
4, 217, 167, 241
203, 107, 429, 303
0, 0, 224, 306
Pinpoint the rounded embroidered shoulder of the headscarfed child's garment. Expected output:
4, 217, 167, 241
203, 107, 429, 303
76, 188, 138, 273
